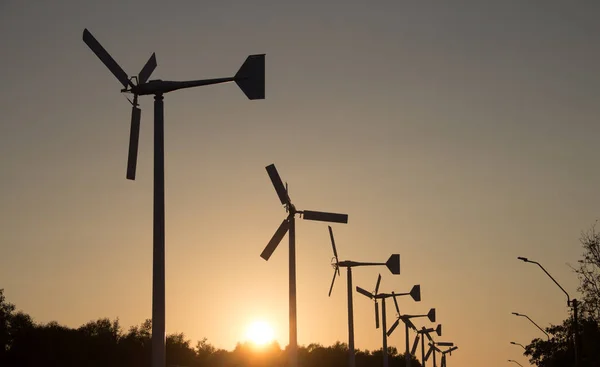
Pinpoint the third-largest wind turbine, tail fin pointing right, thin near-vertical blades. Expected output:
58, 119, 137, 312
328, 226, 404, 367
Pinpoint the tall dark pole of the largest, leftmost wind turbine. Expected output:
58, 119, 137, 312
152, 94, 166, 367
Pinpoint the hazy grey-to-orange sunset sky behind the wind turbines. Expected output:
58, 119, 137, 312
0, 0, 600, 367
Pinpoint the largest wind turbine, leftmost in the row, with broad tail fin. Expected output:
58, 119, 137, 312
83, 29, 265, 367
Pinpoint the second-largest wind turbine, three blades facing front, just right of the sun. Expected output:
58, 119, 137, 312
260, 164, 348, 367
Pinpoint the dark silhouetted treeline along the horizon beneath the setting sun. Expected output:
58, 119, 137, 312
0, 289, 421, 367
